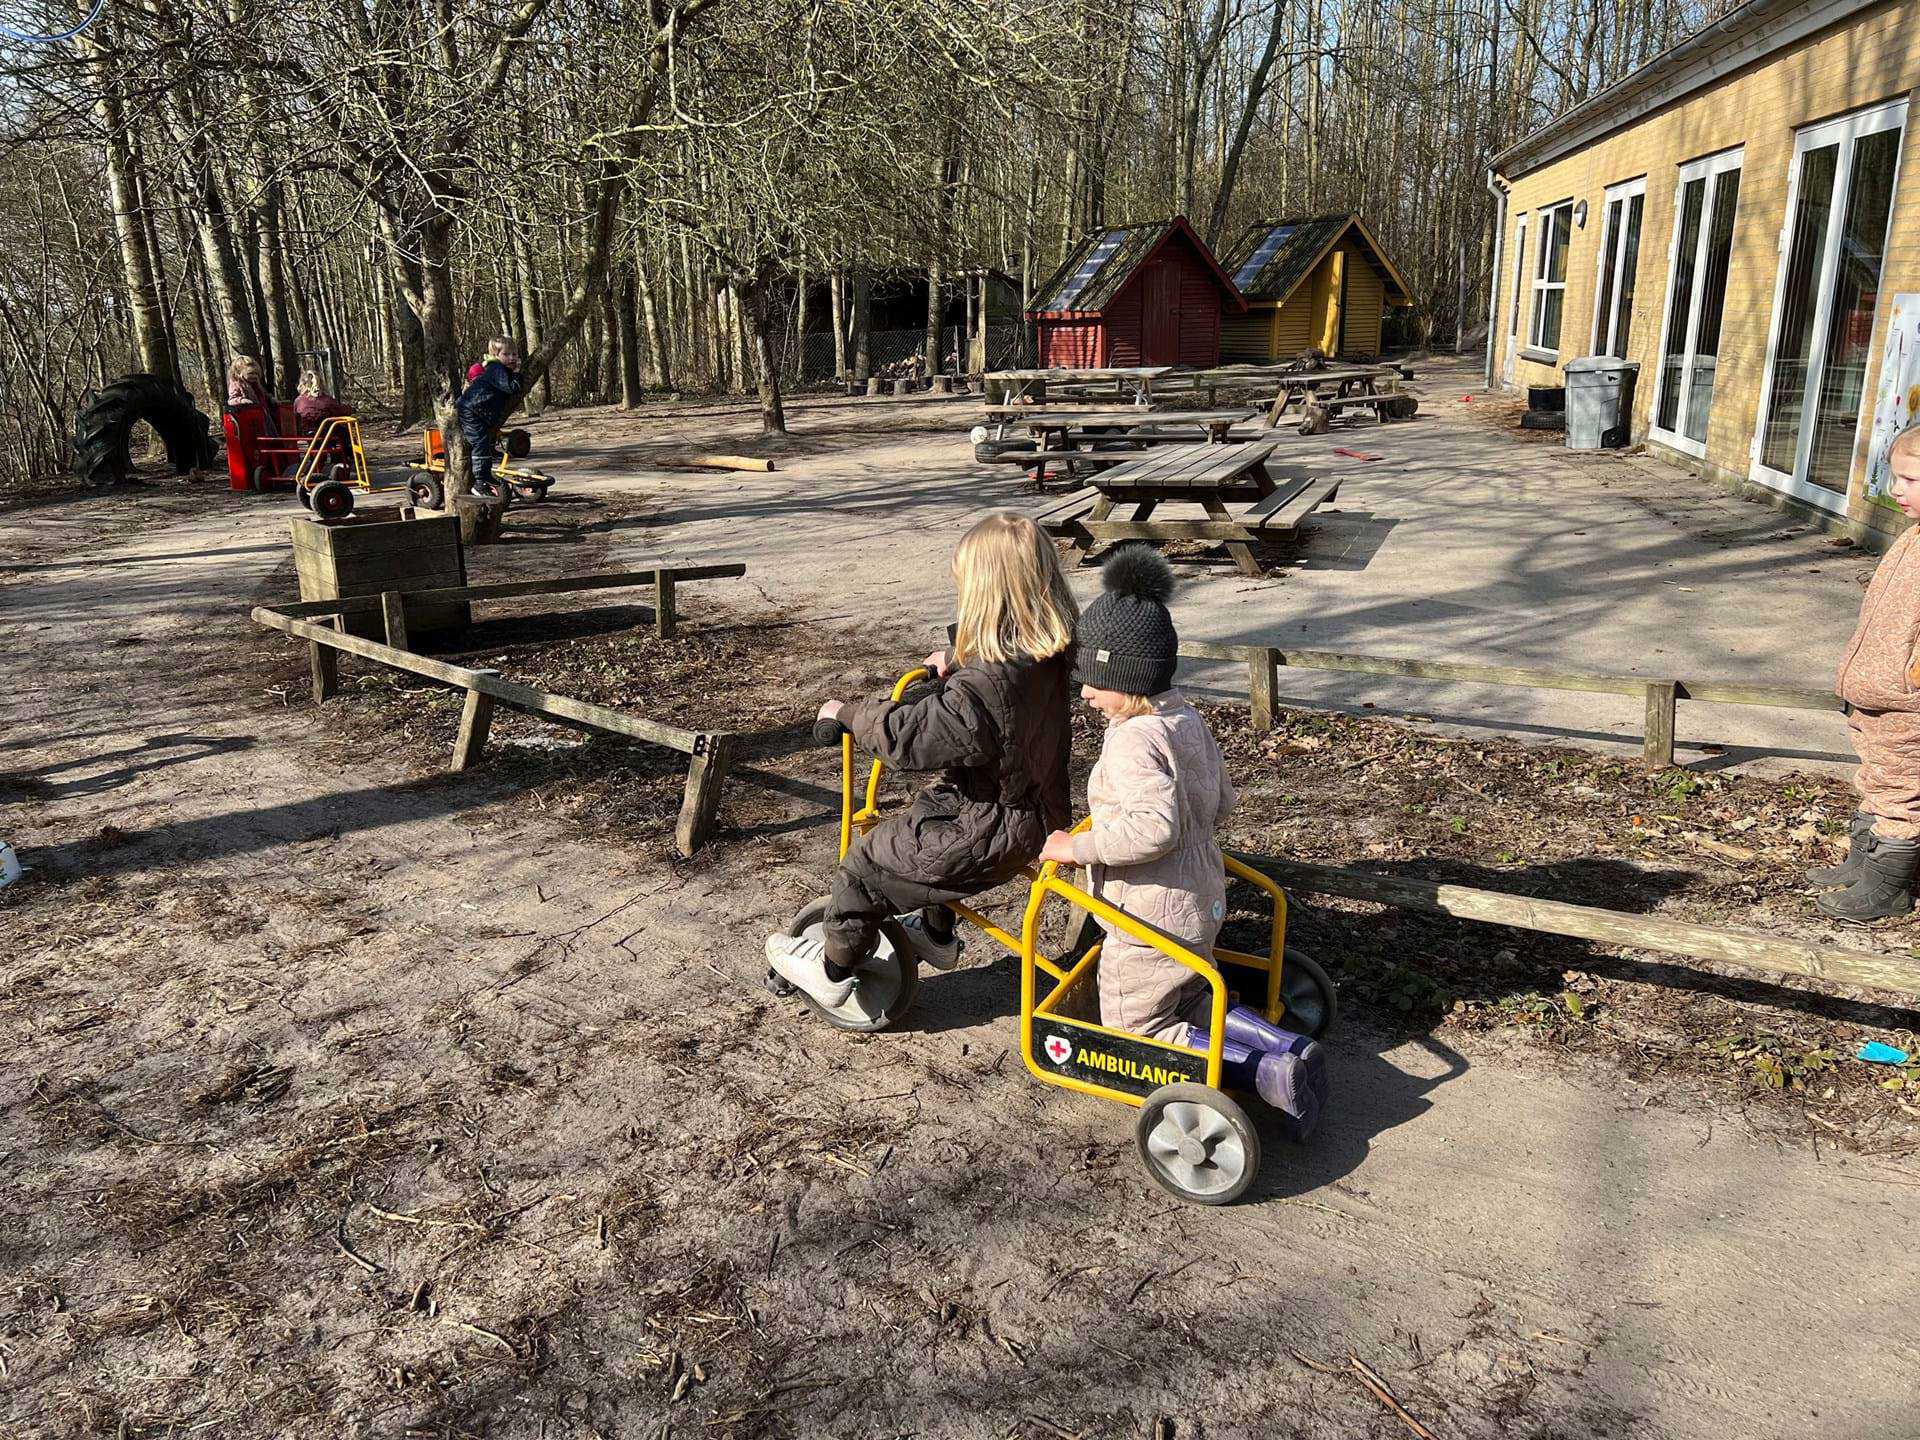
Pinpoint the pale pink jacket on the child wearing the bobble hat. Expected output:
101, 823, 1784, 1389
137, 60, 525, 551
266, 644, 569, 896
1073, 689, 1235, 954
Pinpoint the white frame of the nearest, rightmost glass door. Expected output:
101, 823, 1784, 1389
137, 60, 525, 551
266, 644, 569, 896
1747, 96, 1907, 515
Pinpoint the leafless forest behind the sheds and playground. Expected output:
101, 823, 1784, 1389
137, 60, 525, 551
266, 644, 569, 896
0, 0, 1730, 476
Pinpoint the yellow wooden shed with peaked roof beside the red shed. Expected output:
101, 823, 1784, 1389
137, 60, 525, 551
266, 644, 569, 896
1219, 211, 1413, 365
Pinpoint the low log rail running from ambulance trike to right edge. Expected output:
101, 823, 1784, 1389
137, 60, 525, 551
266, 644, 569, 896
1233, 851, 1920, 996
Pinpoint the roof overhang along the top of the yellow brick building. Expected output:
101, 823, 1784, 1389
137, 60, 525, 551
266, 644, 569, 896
1492, 0, 1893, 179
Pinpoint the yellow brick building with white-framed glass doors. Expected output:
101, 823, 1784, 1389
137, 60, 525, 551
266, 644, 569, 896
1488, 0, 1920, 538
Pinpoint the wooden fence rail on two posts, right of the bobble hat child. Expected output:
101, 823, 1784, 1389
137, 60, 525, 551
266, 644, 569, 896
1181, 641, 1847, 770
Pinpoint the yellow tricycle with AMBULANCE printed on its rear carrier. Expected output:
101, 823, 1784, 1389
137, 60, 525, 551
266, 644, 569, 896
766, 670, 1338, 1206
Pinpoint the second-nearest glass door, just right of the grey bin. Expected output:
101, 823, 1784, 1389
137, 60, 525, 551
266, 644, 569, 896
1653, 150, 1743, 455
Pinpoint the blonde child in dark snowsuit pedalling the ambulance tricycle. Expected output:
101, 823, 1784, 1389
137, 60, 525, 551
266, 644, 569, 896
766, 511, 1077, 1010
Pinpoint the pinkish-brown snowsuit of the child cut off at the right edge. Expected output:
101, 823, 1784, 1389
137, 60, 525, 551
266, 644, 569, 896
1834, 530, 1920, 839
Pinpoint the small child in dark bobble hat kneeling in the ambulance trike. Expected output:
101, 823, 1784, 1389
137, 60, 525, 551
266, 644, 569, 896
1041, 545, 1327, 1139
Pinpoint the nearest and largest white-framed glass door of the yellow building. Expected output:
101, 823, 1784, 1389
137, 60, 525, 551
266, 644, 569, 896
1753, 100, 1907, 511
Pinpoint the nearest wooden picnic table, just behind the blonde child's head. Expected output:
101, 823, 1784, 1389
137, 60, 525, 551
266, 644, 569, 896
1043, 440, 1340, 576
